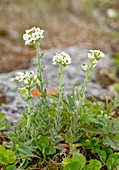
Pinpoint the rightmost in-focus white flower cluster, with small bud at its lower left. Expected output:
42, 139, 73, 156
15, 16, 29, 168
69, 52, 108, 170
81, 50, 105, 72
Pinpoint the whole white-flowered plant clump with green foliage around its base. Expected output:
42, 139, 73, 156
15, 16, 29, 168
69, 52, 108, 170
3, 27, 119, 170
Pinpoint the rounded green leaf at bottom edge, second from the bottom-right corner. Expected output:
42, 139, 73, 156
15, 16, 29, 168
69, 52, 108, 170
85, 159, 102, 170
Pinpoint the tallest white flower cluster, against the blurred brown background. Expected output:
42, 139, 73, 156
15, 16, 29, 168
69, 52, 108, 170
23, 27, 44, 45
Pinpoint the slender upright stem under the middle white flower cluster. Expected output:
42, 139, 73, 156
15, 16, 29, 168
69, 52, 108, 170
59, 64, 63, 104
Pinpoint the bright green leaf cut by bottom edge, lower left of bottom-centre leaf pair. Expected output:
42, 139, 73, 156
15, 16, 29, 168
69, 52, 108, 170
63, 161, 80, 170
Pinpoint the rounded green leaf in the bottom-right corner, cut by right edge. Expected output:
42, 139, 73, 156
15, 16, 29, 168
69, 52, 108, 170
106, 152, 119, 170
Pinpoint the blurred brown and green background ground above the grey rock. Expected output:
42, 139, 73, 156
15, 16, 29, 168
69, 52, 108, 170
0, 0, 119, 73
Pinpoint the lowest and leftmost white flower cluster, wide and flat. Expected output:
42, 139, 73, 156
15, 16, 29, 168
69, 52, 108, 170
12, 71, 38, 85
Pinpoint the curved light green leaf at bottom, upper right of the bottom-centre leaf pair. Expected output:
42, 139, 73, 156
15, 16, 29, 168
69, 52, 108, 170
72, 152, 86, 170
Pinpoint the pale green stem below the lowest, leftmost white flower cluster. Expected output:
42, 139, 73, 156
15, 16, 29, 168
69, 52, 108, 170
26, 88, 31, 129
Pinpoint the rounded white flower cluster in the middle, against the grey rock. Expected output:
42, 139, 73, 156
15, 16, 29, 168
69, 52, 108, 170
52, 52, 71, 66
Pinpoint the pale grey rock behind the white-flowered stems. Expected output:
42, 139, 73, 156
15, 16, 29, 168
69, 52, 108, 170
0, 46, 113, 119
